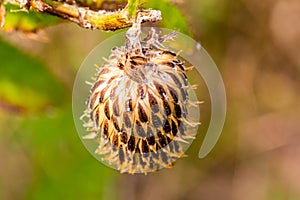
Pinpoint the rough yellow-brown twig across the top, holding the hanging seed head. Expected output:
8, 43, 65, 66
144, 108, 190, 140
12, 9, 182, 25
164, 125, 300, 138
2, 0, 161, 31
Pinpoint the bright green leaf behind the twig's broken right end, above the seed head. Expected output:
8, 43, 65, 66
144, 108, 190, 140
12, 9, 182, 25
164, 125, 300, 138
142, 0, 191, 35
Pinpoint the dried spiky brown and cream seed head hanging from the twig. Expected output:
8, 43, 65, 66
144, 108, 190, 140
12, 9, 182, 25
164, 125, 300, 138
84, 29, 198, 174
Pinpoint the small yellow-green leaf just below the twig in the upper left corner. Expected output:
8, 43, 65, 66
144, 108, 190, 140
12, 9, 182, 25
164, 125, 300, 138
0, 4, 60, 32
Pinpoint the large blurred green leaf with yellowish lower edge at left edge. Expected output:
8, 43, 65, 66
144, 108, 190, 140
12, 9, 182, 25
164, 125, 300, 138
0, 37, 67, 112
